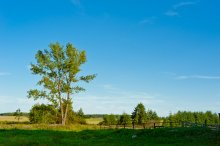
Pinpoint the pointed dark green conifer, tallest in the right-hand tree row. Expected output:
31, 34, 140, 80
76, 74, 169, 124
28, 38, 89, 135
131, 103, 147, 124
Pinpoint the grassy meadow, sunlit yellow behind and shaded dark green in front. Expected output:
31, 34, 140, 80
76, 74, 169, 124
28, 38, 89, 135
0, 116, 220, 146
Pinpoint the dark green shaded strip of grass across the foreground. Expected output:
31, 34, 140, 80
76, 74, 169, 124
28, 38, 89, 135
0, 128, 220, 145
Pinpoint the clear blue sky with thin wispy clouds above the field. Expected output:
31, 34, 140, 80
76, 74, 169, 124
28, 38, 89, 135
0, 0, 220, 116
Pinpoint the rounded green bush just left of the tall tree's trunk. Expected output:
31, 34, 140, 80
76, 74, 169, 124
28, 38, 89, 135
29, 104, 58, 124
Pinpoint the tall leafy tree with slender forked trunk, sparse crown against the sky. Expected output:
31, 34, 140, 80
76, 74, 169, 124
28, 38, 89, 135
28, 43, 96, 125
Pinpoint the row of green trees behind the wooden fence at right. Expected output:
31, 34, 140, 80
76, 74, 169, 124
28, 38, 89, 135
99, 103, 220, 128
